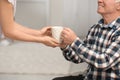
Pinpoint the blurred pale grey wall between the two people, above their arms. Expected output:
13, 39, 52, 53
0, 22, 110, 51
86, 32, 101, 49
16, 0, 100, 37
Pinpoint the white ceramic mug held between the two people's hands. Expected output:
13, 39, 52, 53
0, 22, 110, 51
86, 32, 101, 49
52, 26, 63, 43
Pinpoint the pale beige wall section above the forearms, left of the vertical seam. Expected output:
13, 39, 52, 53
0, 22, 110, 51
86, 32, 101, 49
15, 0, 49, 29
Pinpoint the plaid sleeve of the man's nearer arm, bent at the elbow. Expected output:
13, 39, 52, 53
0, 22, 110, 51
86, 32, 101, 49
71, 31, 120, 70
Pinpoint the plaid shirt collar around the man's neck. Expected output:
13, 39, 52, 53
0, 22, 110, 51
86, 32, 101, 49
98, 17, 120, 29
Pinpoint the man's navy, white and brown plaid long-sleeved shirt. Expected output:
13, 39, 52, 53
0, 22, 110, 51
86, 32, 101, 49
62, 18, 120, 80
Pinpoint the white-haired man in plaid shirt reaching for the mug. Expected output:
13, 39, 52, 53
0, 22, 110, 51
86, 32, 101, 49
53, 0, 120, 80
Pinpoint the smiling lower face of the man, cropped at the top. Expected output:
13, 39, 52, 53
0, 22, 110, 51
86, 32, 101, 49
97, 0, 117, 15
